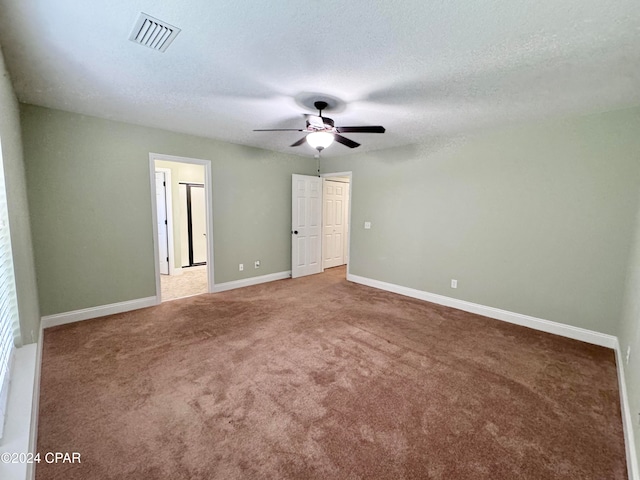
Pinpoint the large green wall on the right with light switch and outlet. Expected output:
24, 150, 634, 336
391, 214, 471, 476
320, 109, 640, 335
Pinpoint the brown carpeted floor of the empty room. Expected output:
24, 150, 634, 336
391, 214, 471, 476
36, 268, 627, 480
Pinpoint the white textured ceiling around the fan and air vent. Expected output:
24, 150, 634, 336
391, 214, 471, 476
0, 0, 640, 156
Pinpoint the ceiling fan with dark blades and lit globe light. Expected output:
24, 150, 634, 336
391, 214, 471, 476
254, 101, 385, 152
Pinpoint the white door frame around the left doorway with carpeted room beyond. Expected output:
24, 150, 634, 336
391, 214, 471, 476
149, 153, 214, 304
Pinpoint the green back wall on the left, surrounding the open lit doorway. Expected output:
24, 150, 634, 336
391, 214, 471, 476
21, 105, 317, 315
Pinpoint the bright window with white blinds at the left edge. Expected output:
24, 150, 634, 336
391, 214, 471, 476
0, 139, 20, 438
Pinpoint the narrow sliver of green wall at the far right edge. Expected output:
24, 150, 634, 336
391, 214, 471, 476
618, 189, 640, 464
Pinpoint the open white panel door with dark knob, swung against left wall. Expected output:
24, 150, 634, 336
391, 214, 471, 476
291, 175, 322, 278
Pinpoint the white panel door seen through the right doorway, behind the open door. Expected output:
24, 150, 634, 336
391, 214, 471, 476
322, 180, 349, 268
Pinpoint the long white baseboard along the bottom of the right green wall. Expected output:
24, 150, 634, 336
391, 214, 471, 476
347, 274, 618, 349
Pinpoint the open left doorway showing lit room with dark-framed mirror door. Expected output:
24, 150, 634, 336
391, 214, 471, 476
149, 154, 213, 302
